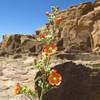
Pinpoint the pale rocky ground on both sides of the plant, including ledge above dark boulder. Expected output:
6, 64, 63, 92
0, 53, 100, 100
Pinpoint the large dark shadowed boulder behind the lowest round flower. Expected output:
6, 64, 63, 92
37, 62, 100, 100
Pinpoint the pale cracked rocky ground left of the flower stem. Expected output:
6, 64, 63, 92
0, 56, 36, 100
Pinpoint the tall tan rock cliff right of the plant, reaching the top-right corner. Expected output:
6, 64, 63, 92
36, 0, 100, 52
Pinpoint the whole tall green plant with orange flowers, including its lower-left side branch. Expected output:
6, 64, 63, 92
13, 6, 62, 100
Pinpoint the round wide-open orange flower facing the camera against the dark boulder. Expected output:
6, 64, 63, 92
48, 69, 62, 86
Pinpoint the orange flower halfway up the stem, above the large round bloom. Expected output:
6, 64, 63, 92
42, 44, 57, 55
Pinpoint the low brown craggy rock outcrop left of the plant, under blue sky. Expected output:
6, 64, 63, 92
0, 34, 41, 55
